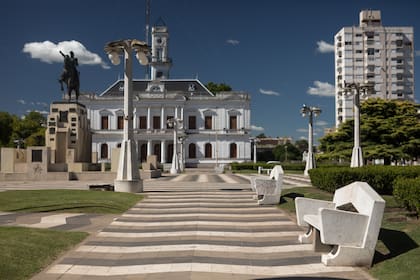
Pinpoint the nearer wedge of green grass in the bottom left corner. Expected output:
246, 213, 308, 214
0, 227, 88, 280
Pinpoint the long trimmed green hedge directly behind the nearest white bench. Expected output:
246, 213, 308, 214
309, 166, 420, 195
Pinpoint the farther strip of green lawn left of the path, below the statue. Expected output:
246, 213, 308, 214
0, 190, 143, 214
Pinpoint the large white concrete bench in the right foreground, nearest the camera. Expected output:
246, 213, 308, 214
295, 182, 385, 266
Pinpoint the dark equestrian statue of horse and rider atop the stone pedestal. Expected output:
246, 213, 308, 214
58, 51, 80, 102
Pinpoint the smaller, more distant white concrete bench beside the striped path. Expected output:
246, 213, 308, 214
251, 165, 284, 205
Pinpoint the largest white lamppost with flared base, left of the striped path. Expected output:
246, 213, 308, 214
105, 39, 149, 192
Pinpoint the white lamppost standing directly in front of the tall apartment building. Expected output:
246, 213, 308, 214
344, 81, 374, 167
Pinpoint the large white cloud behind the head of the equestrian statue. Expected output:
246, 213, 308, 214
22, 40, 110, 69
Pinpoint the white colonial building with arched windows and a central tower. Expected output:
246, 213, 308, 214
79, 21, 251, 167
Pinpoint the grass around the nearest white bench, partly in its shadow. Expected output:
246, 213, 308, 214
279, 187, 420, 280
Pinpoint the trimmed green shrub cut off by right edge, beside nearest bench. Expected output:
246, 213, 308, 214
394, 177, 420, 214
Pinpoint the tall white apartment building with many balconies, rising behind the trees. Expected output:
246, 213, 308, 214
334, 10, 414, 127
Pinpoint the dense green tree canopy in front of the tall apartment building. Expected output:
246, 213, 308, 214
320, 99, 420, 164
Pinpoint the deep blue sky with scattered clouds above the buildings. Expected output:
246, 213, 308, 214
0, 0, 420, 140
